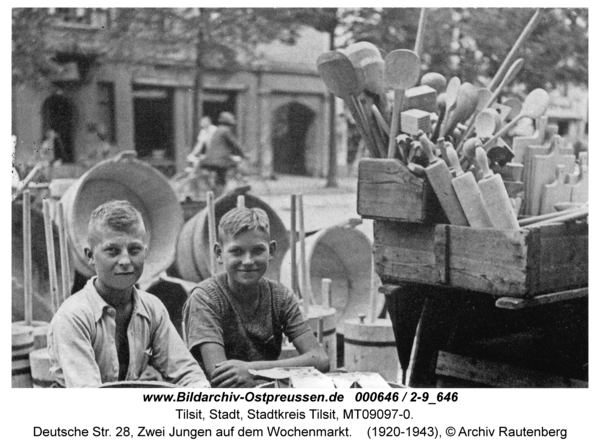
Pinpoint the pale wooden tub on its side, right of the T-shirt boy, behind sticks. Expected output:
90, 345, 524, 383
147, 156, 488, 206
281, 225, 385, 335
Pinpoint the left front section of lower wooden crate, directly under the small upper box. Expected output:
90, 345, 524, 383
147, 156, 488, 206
373, 220, 438, 284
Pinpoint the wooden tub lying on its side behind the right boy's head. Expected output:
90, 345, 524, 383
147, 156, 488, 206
176, 192, 290, 282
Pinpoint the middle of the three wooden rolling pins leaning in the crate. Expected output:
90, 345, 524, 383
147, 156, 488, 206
446, 145, 493, 228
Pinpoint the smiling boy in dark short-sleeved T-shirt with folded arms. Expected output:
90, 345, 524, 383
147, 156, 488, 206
184, 208, 329, 387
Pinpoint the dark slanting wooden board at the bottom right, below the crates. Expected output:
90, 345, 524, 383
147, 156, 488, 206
436, 351, 588, 388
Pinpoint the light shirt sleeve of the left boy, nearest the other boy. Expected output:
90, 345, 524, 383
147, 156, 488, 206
147, 299, 210, 387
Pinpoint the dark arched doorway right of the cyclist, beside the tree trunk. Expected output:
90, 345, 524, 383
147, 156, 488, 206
271, 101, 316, 175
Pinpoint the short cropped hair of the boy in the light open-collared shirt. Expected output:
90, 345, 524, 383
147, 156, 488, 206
88, 200, 147, 246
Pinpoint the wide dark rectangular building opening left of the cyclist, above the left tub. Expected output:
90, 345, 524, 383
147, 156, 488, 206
133, 86, 174, 159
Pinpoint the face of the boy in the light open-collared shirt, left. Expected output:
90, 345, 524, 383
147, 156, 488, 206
85, 225, 147, 290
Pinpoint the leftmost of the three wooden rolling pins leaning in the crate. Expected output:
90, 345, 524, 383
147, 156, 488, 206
419, 133, 469, 226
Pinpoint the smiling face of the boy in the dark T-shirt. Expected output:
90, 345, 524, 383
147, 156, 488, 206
215, 230, 276, 291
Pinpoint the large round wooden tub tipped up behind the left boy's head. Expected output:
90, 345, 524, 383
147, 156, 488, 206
61, 151, 183, 287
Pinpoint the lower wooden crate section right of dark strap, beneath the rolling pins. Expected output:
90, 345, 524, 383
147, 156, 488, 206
434, 223, 589, 297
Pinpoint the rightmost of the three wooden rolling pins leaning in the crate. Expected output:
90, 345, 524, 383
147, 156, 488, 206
475, 146, 519, 229
